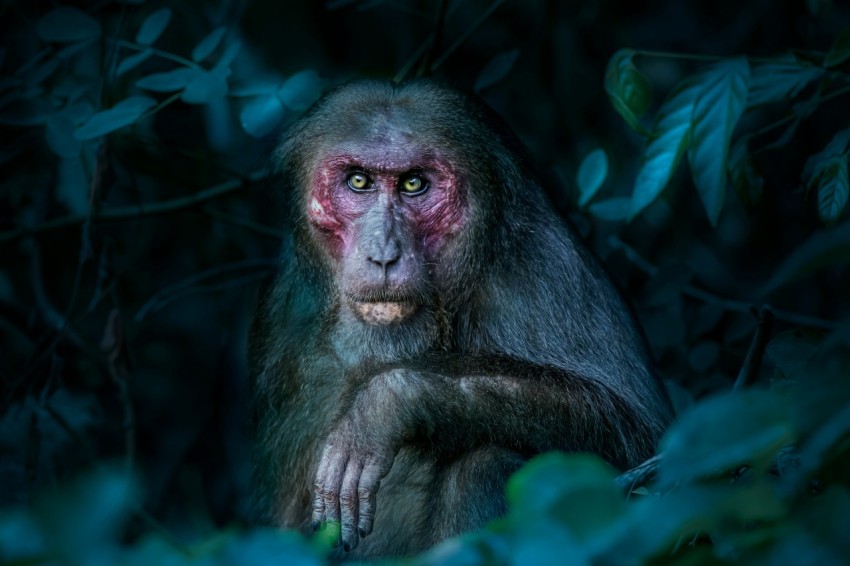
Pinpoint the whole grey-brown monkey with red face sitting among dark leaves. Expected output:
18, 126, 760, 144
249, 79, 672, 559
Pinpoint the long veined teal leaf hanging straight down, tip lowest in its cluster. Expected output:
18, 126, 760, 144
688, 57, 750, 226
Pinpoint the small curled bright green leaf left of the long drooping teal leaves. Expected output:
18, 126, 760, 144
605, 49, 652, 135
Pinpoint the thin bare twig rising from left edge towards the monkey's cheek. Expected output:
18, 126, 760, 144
0, 171, 265, 243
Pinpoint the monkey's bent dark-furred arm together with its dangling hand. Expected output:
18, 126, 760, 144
313, 354, 663, 549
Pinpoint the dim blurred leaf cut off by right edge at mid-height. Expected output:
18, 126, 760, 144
762, 222, 850, 295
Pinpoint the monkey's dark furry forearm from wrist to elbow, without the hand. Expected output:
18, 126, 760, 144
368, 357, 657, 468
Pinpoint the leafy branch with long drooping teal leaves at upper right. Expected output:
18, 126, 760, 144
579, 30, 850, 225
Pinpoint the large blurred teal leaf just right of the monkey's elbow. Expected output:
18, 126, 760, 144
658, 389, 794, 486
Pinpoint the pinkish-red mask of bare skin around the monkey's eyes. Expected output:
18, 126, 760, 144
307, 153, 466, 261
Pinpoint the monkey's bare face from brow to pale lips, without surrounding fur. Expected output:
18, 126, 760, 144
307, 114, 467, 325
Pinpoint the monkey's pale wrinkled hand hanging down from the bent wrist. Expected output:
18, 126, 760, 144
312, 370, 416, 551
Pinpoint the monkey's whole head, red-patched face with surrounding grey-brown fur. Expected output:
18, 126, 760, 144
278, 81, 528, 346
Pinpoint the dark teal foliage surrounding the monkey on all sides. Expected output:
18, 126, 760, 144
0, 0, 850, 564
